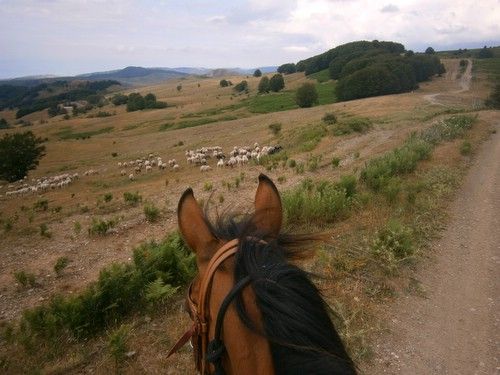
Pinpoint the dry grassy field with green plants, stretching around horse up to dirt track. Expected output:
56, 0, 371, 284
0, 61, 498, 374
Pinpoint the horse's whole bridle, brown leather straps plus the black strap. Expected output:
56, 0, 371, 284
167, 239, 251, 375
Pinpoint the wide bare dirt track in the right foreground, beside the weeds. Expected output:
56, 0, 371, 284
367, 121, 500, 375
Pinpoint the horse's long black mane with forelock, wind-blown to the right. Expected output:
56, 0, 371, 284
206, 215, 356, 375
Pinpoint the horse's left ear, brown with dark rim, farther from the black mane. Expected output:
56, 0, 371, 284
177, 188, 216, 255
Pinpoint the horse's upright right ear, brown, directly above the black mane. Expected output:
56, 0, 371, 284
254, 174, 283, 237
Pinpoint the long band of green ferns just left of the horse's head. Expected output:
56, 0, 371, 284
21, 233, 196, 340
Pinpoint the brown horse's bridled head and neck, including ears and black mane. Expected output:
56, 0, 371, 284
173, 175, 356, 375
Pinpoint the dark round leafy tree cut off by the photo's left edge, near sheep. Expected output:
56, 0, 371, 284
0, 131, 45, 182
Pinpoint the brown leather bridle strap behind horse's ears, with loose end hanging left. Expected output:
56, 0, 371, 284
167, 239, 239, 375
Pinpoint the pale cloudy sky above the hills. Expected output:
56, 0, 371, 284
0, 0, 500, 78
